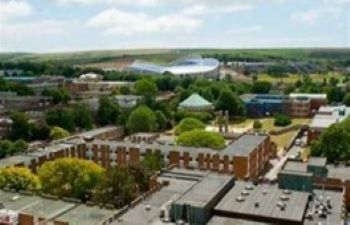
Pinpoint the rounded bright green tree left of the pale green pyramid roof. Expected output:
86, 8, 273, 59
126, 106, 157, 133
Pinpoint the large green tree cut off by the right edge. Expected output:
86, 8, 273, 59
311, 119, 350, 162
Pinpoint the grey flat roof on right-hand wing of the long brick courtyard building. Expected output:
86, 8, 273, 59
221, 134, 267, 156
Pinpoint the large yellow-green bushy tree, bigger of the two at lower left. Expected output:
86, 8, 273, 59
38, 158, 105, 199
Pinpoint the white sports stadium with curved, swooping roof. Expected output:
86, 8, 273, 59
128, 56, 220, 79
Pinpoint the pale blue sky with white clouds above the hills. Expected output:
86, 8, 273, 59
0, 0, 350, 52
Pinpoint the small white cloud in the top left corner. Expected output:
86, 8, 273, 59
0, 1, 32, 21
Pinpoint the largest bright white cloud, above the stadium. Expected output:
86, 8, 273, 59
87, 8, 202, 34
